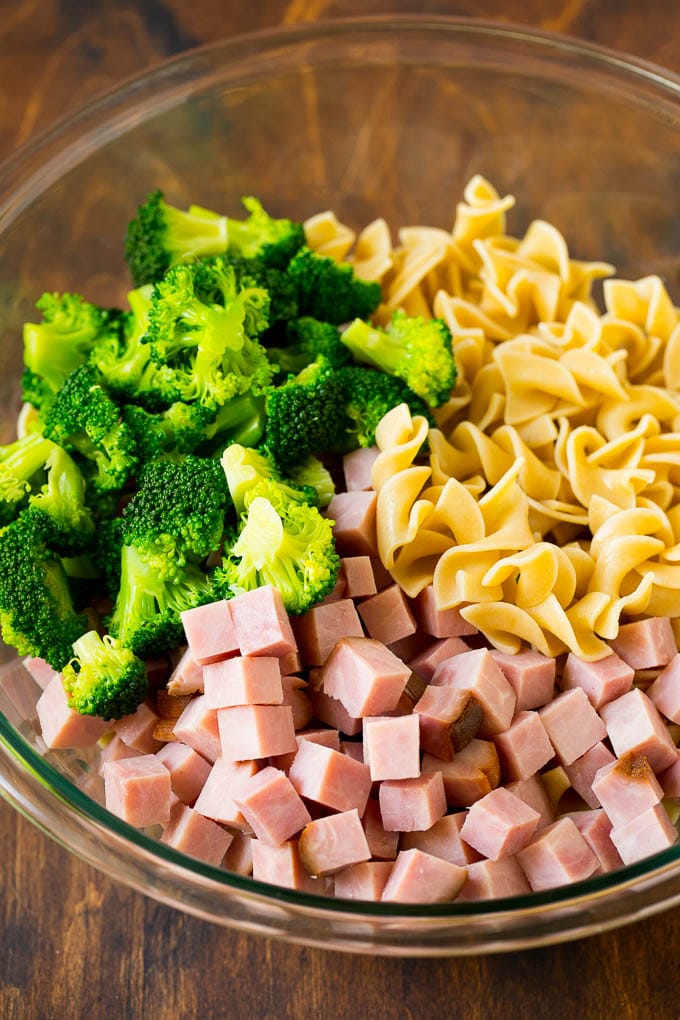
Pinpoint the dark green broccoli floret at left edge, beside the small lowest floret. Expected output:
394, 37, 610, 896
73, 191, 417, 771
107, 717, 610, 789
0, 512, 89, 669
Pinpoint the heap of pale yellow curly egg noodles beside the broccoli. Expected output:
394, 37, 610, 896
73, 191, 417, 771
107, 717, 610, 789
305, 175, 680, 660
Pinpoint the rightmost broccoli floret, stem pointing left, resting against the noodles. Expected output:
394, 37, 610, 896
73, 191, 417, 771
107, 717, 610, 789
341, 311, 456, 407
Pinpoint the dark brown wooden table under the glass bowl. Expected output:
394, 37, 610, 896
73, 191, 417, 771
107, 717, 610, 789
0, 0, 680, 1020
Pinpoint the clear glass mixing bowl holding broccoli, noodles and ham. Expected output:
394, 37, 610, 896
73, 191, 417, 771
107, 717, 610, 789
0, 17, 680, 956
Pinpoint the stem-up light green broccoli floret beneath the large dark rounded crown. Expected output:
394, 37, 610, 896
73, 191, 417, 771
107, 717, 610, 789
106, 546, 213, 659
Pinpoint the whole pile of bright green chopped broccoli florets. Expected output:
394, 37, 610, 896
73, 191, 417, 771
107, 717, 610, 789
0, 191, 456, 719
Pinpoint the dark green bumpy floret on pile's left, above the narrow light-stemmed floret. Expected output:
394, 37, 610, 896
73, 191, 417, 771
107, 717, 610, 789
43, 365, 137, 493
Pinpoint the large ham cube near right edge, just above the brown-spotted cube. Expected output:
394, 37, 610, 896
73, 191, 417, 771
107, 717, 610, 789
600, 687, 678, 771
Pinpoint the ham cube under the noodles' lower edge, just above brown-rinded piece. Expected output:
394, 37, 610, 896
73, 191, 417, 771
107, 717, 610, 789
432, 648, 517, 737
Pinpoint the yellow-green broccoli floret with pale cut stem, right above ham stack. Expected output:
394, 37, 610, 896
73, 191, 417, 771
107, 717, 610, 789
214, 496, 339, 613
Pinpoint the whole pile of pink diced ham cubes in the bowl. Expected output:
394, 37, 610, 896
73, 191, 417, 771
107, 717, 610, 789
27, 451, 680, 904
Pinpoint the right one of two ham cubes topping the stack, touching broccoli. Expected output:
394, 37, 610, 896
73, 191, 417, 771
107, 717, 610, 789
229, 584, 297, 657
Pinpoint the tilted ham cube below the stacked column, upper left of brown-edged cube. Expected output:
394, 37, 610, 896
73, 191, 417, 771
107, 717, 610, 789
233, 765, 312, 847
